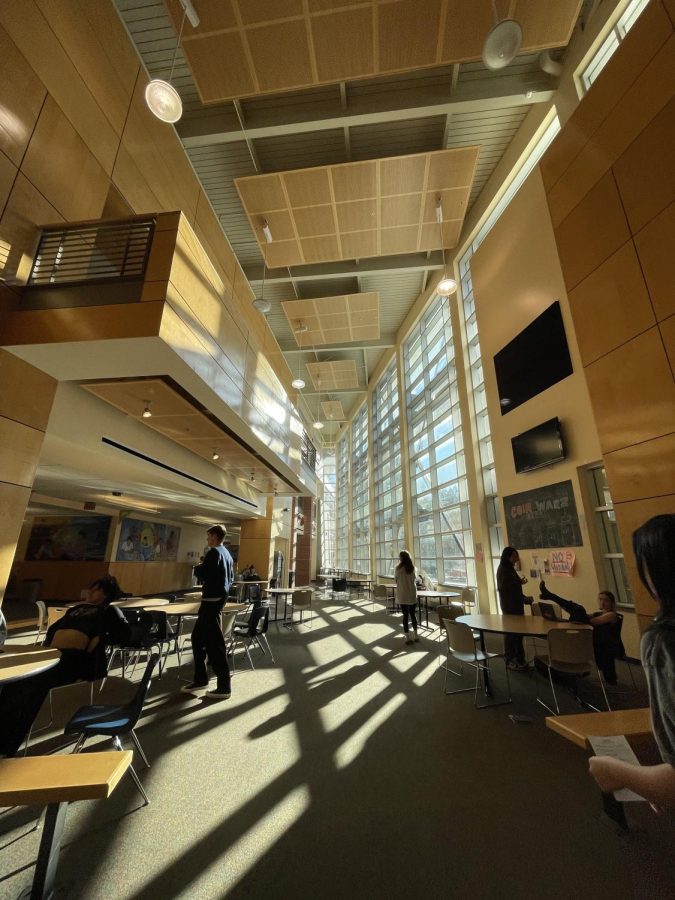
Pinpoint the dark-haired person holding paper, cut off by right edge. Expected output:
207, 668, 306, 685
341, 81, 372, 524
589, 514, 675, 809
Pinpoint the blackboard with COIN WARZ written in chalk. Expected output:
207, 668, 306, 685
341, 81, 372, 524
504, 481, 583, 550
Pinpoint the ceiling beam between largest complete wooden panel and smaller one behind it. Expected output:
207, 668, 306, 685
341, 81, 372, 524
244, 250, 443, 284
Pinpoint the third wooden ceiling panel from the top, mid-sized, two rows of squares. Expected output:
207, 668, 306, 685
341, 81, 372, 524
281, 291, 380, 347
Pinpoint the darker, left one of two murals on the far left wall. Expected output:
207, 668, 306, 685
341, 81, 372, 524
26, 516, 112, 562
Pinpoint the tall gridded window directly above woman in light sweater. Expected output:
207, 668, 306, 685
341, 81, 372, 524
403, 297, 476, 585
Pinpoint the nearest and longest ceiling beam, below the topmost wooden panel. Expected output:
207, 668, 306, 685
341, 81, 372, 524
176, 72, 555, 148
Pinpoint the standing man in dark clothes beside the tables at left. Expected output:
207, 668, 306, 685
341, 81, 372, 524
181, 525, 234, 700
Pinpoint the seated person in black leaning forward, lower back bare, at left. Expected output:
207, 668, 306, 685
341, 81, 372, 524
0, 575, 130, 756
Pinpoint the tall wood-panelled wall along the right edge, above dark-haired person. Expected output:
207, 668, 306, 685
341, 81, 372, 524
542, 0, 675, 628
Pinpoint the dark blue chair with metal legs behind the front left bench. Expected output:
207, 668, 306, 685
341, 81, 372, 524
63, 653, 160, 806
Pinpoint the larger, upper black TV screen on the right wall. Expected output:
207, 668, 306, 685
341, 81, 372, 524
495, 300, 573, 415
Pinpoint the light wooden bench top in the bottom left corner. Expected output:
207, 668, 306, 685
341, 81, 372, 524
0, 750, 133, 806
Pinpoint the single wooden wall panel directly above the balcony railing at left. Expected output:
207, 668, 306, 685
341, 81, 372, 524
21, 97, 110, 221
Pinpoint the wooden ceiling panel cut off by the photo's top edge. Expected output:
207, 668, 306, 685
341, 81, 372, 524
165, 0, 582, 103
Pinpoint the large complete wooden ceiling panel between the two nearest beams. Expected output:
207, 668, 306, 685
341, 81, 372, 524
235, 147, 480, 268
